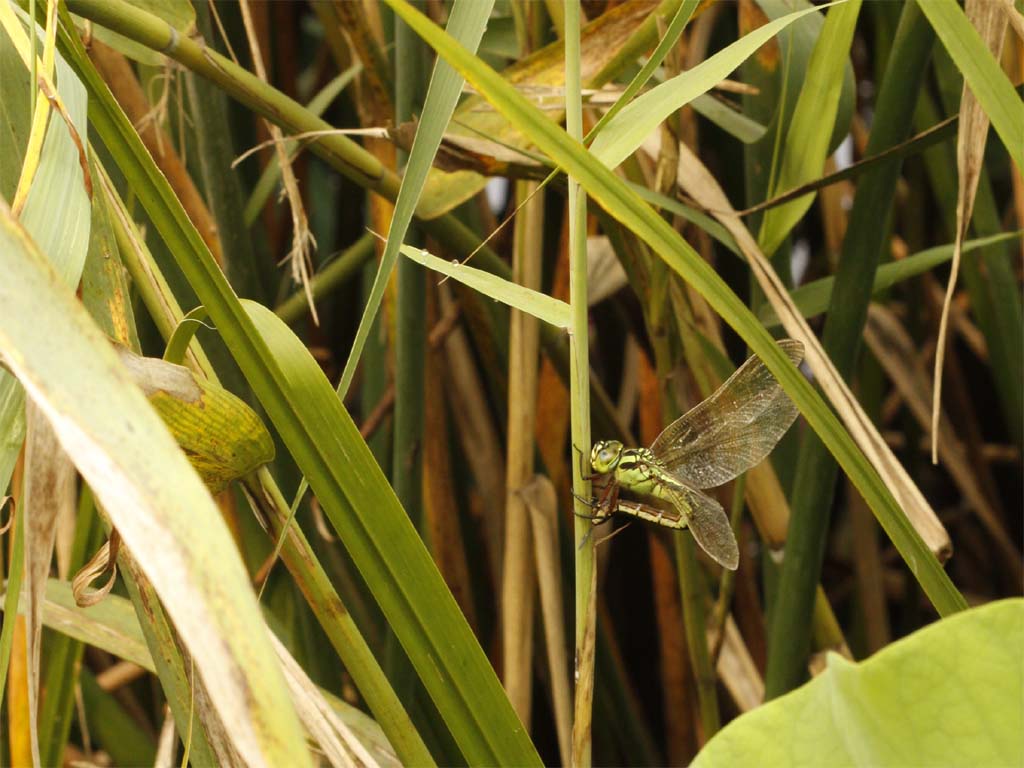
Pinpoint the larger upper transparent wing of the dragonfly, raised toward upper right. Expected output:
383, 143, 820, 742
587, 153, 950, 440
650, 339, 804, 488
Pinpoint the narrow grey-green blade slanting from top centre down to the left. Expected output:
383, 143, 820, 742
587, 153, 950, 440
338, 0, 494, 398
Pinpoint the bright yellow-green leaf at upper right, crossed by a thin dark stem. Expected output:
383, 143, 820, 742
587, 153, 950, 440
758, 0, 860, 258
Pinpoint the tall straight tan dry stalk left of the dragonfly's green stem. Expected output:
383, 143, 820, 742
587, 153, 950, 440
502, 181, 544, 727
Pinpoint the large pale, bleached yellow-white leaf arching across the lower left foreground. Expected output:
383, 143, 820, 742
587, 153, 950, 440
0, 206, 309, 765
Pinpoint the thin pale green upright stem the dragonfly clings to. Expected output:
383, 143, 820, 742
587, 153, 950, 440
565, 7, 597, 768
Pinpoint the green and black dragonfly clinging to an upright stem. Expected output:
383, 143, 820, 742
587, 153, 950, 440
587, 339, 804, 570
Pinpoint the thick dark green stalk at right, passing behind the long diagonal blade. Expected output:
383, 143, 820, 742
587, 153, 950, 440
765, 3, 935, 698
